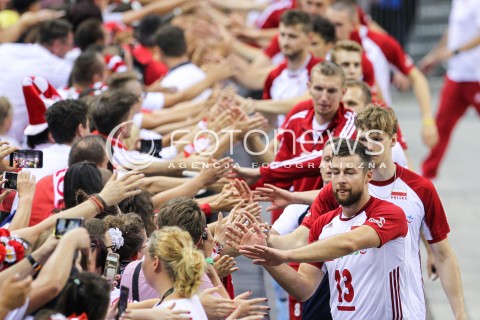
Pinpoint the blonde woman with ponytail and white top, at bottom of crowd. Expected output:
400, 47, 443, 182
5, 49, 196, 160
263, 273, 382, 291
142, 227, 207, 320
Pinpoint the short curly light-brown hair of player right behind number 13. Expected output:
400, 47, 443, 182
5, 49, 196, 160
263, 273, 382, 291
355, 103, 398, 137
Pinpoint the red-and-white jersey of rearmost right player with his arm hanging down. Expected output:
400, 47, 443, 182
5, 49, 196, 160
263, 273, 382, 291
350, 26, 414, 106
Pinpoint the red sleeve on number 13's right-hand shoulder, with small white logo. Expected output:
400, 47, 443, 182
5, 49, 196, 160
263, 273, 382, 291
364, 198, 408, 246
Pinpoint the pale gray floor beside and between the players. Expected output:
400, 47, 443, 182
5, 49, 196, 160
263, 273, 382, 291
234, 79, 480, 320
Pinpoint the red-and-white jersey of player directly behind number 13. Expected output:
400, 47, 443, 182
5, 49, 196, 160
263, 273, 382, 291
302, 165, 450, 319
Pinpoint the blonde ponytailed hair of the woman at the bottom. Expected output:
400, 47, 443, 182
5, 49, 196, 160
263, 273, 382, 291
148, 227, 205, 298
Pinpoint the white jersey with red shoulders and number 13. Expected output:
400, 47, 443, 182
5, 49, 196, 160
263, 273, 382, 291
308, 197, 408, 320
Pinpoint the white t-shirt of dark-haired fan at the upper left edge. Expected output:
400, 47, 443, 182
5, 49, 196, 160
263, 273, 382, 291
0, 43, 72, 141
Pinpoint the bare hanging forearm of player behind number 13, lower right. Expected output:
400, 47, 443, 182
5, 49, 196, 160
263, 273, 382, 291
431, 239, 467, 319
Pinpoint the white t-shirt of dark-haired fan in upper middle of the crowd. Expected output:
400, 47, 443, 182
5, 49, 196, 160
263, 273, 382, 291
161, 62, 212, 102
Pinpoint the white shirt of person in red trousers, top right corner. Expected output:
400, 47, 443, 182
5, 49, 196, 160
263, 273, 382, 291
447, 0, 480, 82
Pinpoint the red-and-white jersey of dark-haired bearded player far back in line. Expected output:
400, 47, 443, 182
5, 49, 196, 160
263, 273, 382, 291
262, 55, 323, 100
